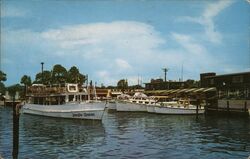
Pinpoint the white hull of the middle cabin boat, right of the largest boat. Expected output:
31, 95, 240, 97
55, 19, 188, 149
116, 101, 147, 112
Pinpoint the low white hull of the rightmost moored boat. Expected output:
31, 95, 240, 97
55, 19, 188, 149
155, 106, 205, 115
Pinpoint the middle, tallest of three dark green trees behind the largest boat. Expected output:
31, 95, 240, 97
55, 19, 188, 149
52, 64, 67, 84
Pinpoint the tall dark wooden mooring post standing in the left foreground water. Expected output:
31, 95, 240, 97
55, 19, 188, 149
12, 97, 20, 159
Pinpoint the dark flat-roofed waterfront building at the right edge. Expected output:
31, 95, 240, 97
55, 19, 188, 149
200, 72, 250, 112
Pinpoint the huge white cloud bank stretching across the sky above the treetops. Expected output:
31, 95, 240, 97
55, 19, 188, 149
3, 21, 227, 85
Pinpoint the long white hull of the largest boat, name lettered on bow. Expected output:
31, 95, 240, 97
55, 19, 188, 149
22, 102, 105, 120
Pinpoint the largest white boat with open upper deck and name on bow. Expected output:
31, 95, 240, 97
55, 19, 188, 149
22, 84, 105, 120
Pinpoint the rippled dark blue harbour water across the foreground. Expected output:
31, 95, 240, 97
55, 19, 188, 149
0, 107, 250, 159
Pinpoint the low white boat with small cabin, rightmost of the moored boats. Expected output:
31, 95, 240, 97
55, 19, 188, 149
155, 100, 205, 115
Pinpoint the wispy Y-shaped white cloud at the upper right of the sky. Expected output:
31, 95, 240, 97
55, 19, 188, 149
177, 0, 233, 43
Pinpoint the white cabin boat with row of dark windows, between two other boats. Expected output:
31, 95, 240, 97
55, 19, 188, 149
116, 92, 155, 112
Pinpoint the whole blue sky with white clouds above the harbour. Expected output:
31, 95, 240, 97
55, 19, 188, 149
0, 0, 250, 86
